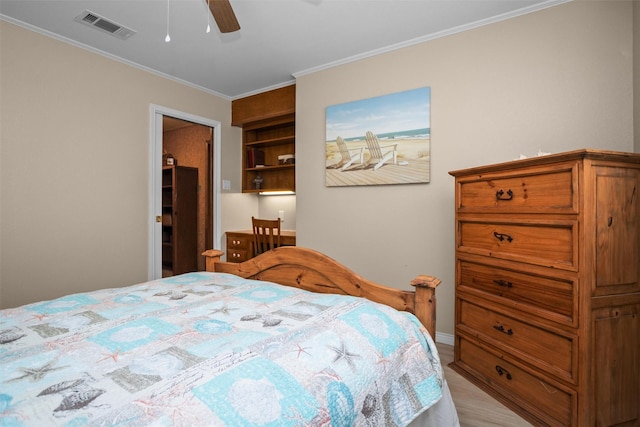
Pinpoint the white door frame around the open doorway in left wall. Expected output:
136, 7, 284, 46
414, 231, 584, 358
147, 104, 221, 280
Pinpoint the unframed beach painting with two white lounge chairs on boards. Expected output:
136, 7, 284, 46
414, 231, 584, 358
325, 87, 431, 187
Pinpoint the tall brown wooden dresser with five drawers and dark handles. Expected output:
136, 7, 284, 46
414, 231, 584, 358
450, 150, 640, 426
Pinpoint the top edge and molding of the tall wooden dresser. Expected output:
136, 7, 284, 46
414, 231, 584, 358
449, 148, 640, 176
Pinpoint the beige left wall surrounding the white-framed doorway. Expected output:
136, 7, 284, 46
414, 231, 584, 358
0, 21, 240, 307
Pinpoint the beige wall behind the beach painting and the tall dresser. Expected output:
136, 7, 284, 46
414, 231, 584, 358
296, 1, 634, 342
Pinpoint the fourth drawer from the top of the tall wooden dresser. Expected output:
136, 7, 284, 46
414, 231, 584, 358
457, 299, 577, 383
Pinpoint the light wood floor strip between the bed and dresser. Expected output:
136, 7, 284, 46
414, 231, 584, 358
436, 343, 531, 427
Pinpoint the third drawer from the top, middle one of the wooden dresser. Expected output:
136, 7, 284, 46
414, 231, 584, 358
457, 259, 578, 326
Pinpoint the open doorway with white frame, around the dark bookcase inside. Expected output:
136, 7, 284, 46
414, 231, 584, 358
149, 105, 220, 280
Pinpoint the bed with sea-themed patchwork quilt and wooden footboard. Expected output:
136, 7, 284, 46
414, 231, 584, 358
0, 247, 458, 426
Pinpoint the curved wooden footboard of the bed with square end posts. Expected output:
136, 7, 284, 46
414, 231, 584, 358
202, 246, 441, 341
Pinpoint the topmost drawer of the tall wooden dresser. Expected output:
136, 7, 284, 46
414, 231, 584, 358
457, 163, 577, 213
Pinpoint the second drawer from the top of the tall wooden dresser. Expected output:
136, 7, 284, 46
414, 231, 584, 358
457, 220, 578, 271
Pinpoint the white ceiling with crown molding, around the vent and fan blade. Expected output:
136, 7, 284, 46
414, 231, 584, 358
0, 0, 567, 99
